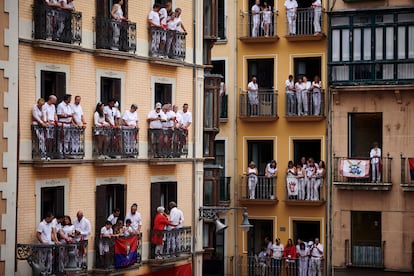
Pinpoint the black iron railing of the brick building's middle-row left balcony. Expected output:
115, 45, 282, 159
32, 124, 85, 160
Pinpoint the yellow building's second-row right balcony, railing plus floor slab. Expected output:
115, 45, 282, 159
285, 90, 325, 122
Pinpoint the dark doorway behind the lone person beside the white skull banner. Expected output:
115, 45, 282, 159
348, 112, 384, 158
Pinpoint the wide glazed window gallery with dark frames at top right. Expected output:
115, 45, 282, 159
329, 9, 414, 84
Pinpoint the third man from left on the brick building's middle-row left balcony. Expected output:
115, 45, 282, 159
57, 94, 73, 158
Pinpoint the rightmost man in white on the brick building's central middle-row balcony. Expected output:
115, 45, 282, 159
122, 104, 138, 157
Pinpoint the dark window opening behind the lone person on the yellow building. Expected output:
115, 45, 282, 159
246, 58, 274, 90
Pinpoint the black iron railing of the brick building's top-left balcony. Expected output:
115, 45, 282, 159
33, 1, 82, 45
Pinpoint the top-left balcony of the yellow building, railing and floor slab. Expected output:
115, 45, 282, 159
239, 11, 279, 43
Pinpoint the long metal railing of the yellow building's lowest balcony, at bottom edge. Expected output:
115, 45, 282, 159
237, 255, 325, 276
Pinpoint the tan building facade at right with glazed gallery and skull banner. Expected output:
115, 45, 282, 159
328, 0, 414, 272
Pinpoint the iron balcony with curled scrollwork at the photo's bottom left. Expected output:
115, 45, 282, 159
16, 241, 88, 275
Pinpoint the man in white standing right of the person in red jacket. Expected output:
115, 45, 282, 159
167, 201, 184, 257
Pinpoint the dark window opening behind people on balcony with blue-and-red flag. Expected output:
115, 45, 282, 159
95, 184, 126, 234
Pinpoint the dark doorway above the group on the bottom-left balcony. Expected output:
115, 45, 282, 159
40, 186, 65, 221
